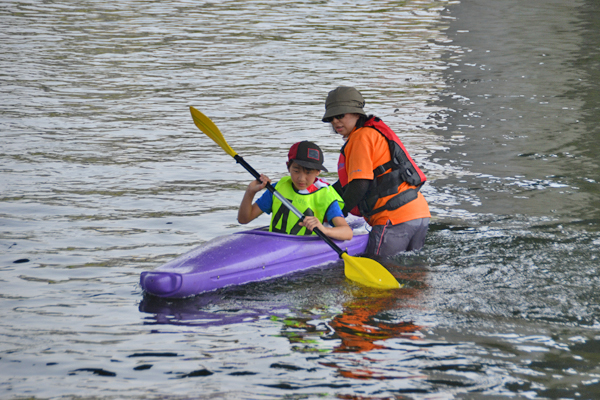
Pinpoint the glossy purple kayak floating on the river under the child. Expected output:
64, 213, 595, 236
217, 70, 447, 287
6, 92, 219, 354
140, 221, 368, 298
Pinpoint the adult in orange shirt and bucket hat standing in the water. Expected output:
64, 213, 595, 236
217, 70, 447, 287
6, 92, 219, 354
322, 86, 431, 257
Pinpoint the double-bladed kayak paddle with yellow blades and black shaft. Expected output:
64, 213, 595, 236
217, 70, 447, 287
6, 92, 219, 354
190, 107, 400, 289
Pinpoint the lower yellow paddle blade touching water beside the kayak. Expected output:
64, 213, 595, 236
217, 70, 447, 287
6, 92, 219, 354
342, 253, 400, 289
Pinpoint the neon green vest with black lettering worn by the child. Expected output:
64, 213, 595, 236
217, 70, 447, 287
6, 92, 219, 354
269, 176, 344, 235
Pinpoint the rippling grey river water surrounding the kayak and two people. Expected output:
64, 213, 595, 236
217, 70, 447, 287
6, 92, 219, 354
0, 0, 600, 399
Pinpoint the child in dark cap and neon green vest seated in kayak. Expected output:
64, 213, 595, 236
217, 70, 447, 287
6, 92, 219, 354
238, 141, 352, 240
